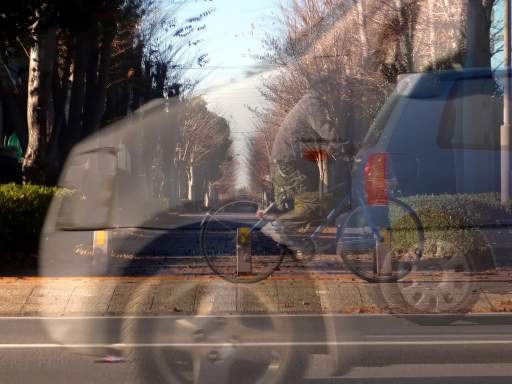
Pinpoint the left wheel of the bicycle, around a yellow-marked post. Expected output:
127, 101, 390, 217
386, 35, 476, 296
201, 200, 285, 283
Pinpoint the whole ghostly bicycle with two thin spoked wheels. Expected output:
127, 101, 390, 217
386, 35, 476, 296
201, 188, 425, 283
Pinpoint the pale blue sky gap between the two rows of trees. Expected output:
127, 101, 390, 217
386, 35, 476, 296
171, 0, 282, 185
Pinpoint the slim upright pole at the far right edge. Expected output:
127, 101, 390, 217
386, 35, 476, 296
500, 0, 511, 205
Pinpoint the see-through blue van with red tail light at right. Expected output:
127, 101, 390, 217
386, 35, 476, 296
338, 69, 512, 311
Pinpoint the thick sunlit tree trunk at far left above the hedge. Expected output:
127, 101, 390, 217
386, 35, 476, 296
23, 18, 56, 183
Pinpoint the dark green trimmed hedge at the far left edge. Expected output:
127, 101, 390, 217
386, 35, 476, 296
0, 183, 68, 256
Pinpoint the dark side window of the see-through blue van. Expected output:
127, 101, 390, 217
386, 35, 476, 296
437, 78, 503, 149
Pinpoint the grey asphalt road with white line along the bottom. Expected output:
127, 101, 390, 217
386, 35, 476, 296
0, 315, 512, 383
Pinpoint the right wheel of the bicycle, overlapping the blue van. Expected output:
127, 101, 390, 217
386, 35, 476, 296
338, 199, 425, 282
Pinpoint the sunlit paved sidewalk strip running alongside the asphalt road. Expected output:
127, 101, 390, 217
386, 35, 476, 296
0, 277, 512, 316
